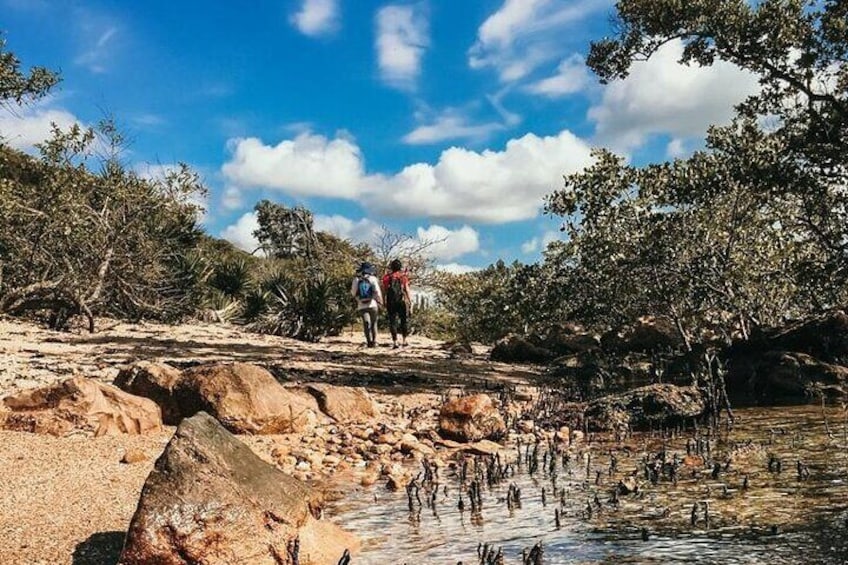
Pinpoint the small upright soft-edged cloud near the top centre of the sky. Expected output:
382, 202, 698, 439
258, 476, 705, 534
376, 4, 430, 90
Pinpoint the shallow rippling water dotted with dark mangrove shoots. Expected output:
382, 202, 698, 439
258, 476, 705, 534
328, 406, 848, 565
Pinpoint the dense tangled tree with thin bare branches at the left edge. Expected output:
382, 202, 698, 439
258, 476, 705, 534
0, 122, 204, 331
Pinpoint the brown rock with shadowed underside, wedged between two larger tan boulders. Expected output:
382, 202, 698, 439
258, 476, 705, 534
114, 361, 183, 426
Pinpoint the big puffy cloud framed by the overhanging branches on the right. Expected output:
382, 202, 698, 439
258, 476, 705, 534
589, 41, 759, 151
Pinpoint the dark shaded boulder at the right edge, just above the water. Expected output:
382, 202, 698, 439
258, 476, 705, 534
727, 351, 848, 400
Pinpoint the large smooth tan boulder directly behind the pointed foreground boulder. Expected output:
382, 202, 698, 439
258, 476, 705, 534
174, 363, 318, 434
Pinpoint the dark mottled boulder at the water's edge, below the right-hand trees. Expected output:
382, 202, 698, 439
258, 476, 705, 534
585, 384, 706, 430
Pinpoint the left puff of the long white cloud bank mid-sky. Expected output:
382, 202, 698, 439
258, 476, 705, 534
222, 133, 364, 198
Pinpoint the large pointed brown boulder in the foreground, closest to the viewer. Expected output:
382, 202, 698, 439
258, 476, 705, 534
121, 412, 359, 565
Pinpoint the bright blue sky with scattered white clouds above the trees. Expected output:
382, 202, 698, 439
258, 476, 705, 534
0, 0, 757, 271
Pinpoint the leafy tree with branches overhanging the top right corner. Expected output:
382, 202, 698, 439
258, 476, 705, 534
587, 0, 848, 288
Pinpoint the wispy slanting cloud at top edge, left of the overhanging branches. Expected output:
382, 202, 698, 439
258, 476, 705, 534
468, 0, 612, 82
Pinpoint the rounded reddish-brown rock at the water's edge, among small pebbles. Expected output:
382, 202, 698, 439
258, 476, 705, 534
439, 394, 506, 442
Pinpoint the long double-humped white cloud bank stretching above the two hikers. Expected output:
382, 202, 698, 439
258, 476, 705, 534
223, 130, 590, 223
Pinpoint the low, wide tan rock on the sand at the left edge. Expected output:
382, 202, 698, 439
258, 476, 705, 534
0, 377, 162, 436
